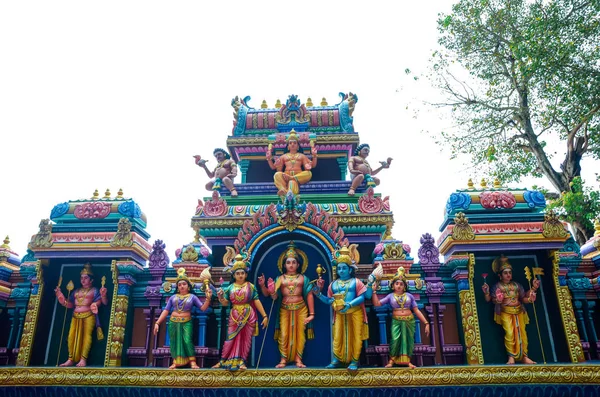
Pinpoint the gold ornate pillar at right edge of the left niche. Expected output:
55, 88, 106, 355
104, 260, 142, 367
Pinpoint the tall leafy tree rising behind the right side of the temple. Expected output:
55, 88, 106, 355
430, 0, 600, 244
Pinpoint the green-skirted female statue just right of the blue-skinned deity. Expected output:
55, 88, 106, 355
367, 267, 429, 368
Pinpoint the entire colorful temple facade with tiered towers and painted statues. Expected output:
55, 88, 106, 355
0, 93, 600, 396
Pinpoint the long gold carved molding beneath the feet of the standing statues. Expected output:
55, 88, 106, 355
0, 364, 600, 388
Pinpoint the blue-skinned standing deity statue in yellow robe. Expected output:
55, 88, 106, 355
313, 244, 373, 371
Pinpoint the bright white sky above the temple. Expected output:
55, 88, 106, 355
0, 0, 590, 260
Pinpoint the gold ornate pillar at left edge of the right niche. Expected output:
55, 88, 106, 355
449, 254, 483, 365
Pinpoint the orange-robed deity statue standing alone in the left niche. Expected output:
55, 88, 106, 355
54, 264, 108, 367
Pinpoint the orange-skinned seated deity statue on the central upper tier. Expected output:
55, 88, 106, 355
266, 129, 317, 196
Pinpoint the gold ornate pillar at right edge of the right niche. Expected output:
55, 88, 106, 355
552, 251, 584, 363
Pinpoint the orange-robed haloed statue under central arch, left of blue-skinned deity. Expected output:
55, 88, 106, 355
258, 241, 315, 368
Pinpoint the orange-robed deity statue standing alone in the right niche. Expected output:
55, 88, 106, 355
481, 255, 540, 365
